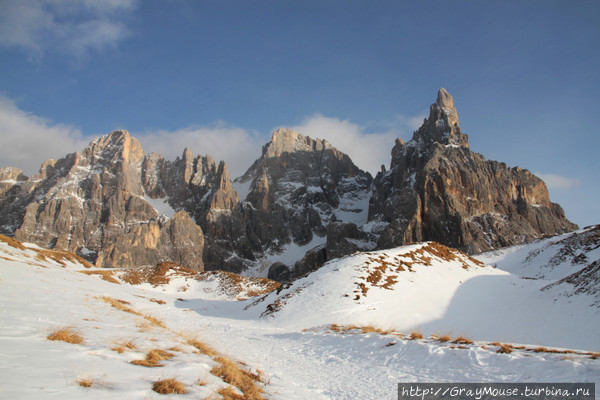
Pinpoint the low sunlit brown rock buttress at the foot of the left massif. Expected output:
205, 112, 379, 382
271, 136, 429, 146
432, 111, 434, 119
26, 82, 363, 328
96, 211, 204, 271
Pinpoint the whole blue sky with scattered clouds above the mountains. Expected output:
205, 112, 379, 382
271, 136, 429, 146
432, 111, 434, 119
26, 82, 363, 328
0, 0, 600, 227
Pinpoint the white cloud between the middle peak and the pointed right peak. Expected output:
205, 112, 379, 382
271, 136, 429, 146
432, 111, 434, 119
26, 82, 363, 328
290, 114, 423, 175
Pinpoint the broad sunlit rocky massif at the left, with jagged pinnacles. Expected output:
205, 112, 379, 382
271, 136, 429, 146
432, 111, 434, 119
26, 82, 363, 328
0, 131, 232, 270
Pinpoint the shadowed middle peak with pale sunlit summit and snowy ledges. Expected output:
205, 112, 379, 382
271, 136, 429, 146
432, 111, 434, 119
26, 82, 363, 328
236, 129, 372, 252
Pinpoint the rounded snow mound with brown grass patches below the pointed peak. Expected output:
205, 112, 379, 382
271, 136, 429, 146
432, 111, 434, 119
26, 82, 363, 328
248, 242, 600, 350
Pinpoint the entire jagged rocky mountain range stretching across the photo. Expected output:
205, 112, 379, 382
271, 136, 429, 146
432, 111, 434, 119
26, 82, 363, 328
0, 89, 577, 281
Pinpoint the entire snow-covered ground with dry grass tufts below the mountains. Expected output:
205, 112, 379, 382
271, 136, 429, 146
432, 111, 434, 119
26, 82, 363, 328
0, 233, 600, 399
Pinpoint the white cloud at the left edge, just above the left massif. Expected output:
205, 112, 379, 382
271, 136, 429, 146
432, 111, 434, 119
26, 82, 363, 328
0, 97, 89, 176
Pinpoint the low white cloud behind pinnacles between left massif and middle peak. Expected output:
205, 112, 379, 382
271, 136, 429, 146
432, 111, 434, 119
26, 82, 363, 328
132, 123, 263, 180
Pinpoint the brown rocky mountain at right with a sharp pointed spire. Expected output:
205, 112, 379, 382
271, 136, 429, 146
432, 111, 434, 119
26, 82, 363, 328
369, 89, 576, 254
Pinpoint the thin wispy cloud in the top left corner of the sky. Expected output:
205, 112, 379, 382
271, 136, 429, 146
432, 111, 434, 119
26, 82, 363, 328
0, 0, 138, 61
